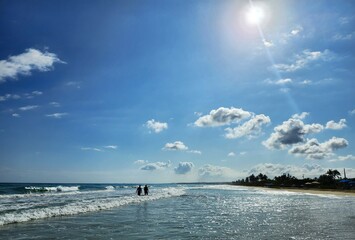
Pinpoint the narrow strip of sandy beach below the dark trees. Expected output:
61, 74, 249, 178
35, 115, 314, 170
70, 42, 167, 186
245, 185, 355, 197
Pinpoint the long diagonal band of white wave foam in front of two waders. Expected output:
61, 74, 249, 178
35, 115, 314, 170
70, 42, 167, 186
0, 187, 185, 225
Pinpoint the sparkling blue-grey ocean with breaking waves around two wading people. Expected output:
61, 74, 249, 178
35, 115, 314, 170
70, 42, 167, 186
0, 183, 355, 240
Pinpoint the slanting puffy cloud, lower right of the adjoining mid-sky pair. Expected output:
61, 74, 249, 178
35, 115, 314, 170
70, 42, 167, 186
225, 114, 271, 139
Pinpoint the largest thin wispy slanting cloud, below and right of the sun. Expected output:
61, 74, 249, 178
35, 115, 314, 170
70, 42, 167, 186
273, 49, 334, 72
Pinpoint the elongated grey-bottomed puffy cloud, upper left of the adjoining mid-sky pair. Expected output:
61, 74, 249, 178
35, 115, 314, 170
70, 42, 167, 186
194, 107, 251, 127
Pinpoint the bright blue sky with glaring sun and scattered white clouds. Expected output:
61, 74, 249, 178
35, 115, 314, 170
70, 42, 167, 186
0, 0, 355, 183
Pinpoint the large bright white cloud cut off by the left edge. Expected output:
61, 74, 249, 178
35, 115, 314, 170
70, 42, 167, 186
0, 48, 64, 82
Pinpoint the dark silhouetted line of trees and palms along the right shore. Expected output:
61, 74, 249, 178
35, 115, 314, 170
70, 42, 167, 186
233, 169, 355, 189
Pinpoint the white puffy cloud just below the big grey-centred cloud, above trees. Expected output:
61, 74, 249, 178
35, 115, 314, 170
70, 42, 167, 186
289, 137, 348, 159
